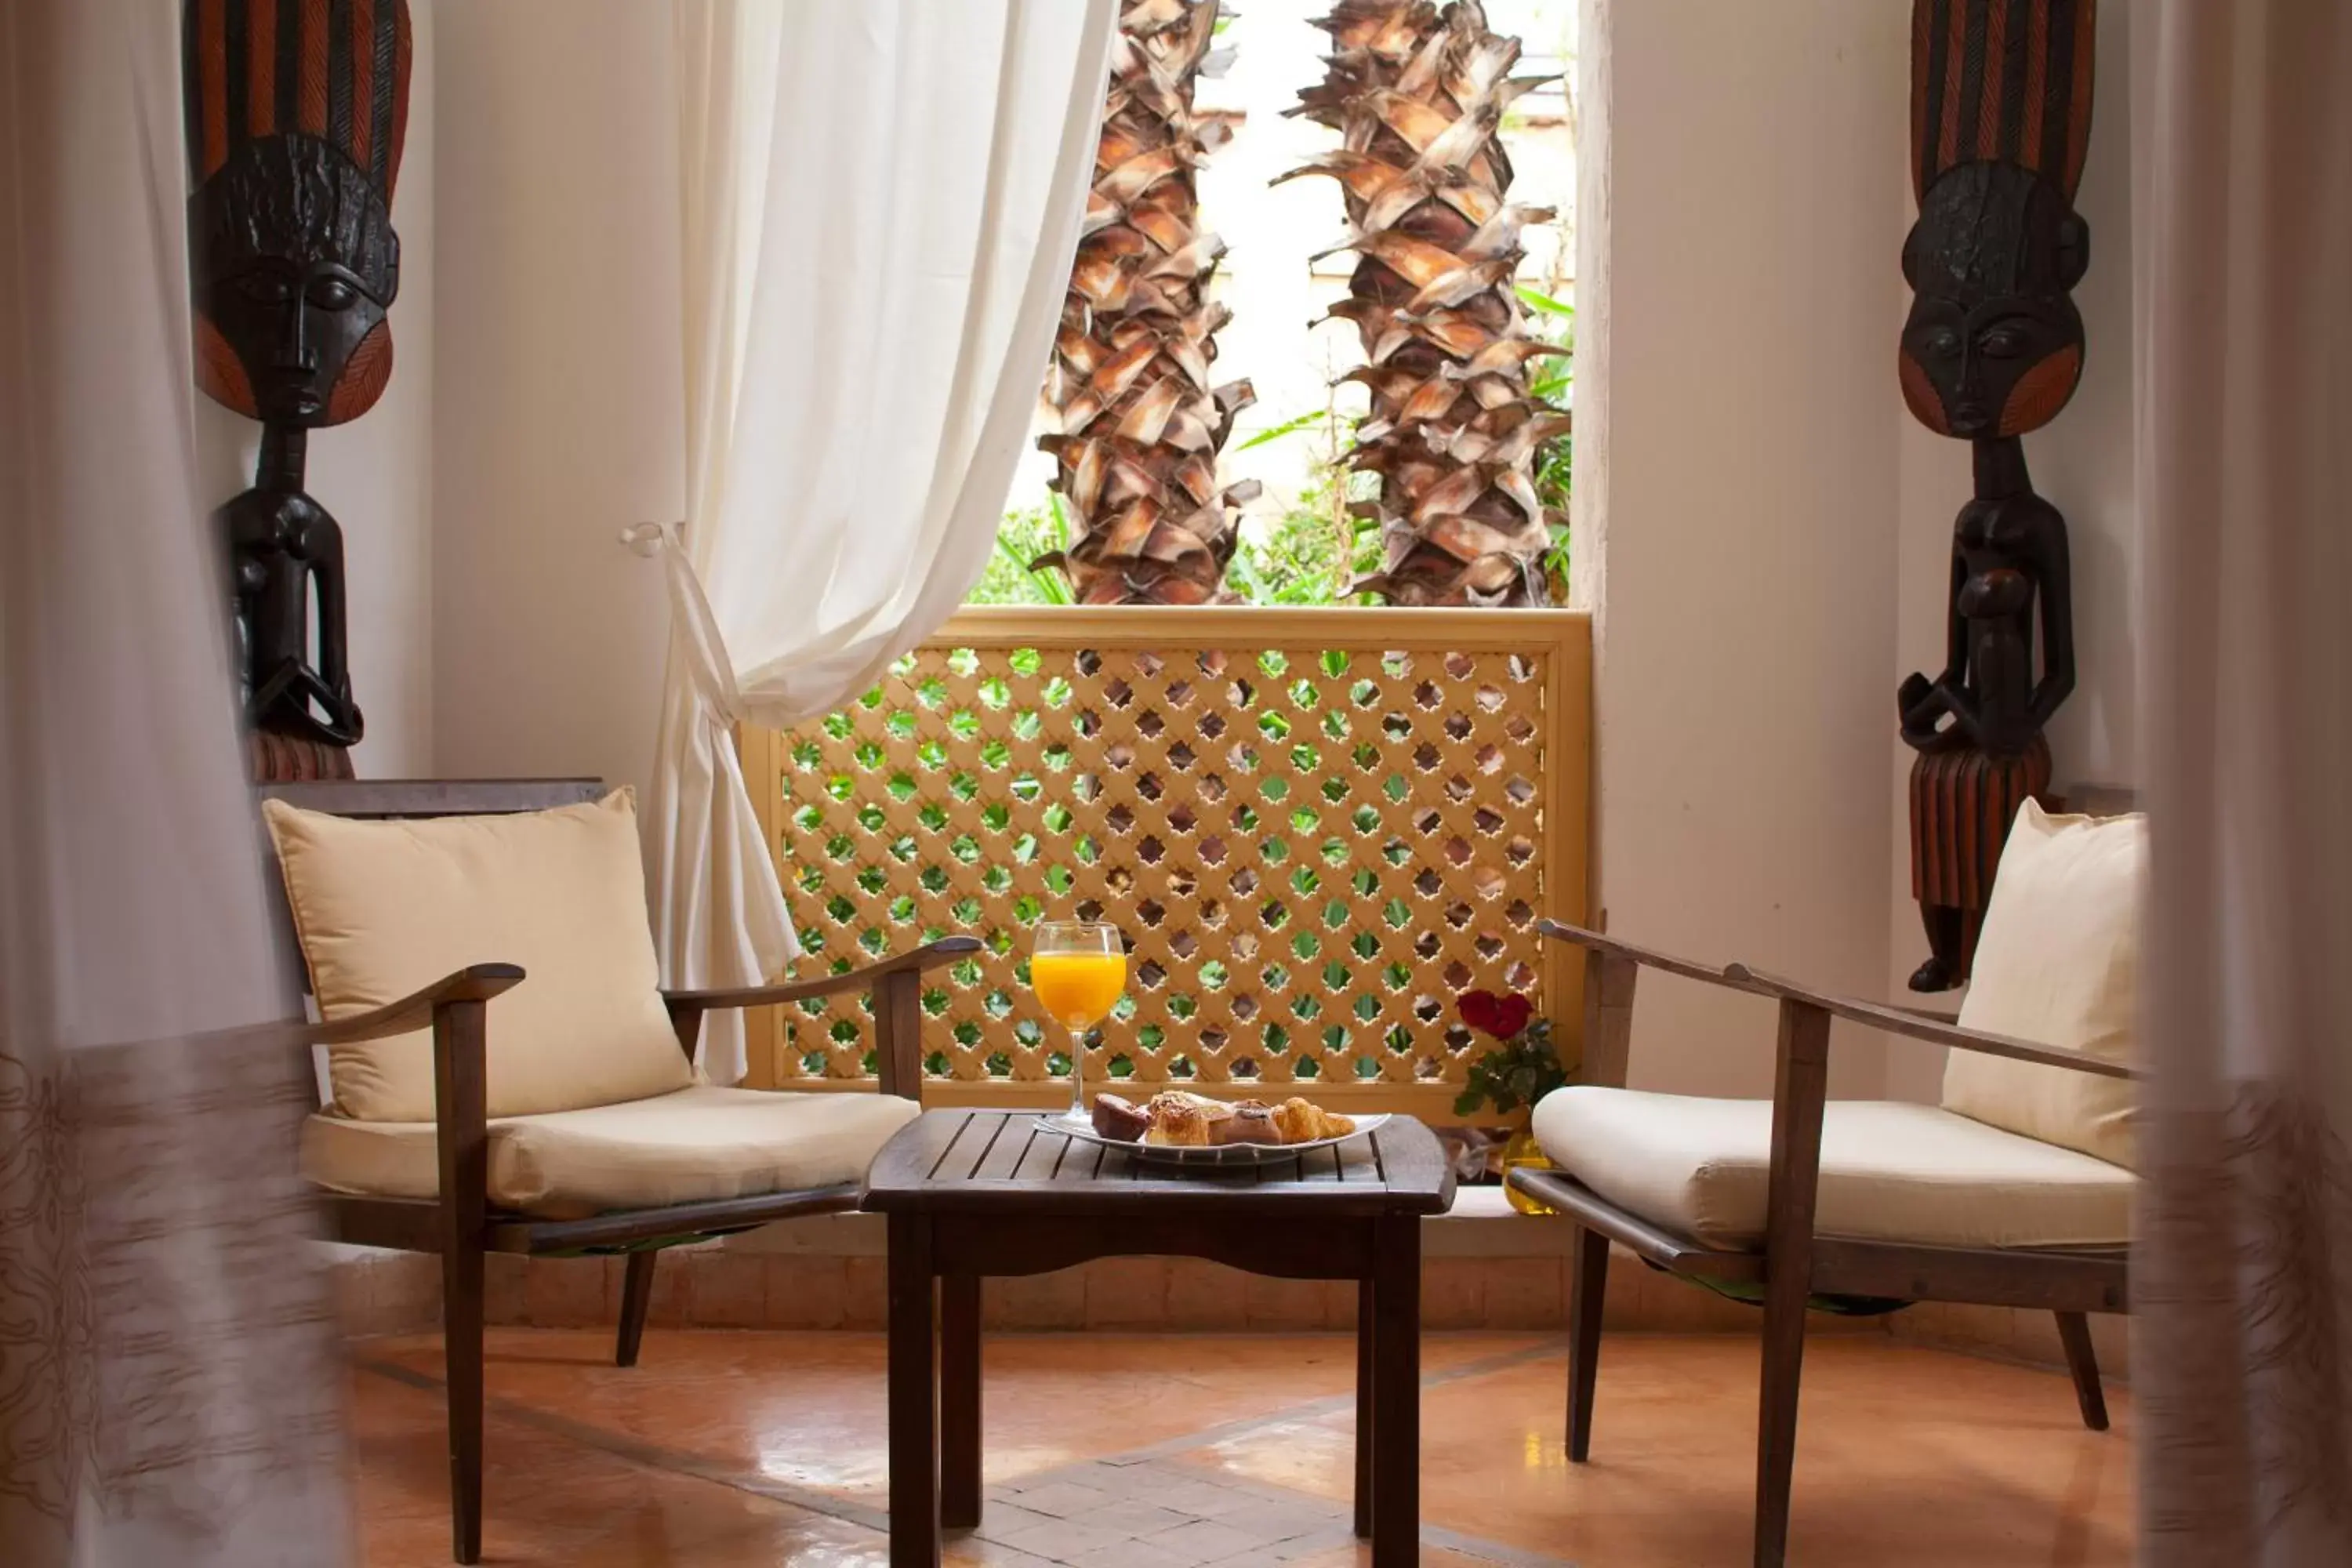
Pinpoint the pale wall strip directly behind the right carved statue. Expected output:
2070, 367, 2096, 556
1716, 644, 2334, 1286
1884, 5, 2140, 1100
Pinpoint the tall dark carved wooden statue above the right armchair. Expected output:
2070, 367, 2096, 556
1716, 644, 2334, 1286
1898, 0, 2096, 992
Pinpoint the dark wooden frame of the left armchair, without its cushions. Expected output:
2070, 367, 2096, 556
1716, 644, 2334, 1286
261, 781, 978, 1563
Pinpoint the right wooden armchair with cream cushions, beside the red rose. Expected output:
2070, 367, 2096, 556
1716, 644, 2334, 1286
1510, 811, 2145, 1568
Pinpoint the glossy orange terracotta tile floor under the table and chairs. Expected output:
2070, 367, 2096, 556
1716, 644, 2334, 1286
353, 1328, 2133, 1568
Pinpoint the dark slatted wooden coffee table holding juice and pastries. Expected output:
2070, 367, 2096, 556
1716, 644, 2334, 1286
866, 1109, 1454, 1568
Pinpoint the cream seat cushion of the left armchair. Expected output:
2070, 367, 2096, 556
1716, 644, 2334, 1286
303, 1086, 922, 1220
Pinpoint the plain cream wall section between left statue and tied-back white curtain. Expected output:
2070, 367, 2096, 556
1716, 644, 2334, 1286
433, 0, 682, 792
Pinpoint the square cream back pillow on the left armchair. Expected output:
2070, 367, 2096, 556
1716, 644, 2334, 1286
261, 789, 694, 1121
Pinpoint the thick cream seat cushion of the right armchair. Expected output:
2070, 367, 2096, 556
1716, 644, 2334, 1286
1534, 1083, 2133, 1248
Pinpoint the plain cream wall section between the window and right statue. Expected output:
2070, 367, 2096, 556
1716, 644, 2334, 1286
1576, 0, 1910, 1093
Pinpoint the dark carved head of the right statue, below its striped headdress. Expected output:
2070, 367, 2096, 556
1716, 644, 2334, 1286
1900, 162, 2091, 440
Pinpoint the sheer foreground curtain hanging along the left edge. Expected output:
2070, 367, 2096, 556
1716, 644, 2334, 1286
0, 0, 350, 1568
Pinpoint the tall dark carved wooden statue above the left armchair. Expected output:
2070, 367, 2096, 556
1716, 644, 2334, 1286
181, 0, 412, 781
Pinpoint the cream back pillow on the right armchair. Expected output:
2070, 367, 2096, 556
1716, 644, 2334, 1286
1943, 801, 2147, 1166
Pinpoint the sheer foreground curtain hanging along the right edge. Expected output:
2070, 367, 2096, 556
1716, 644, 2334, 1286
2131, 0, 2352, 1568
